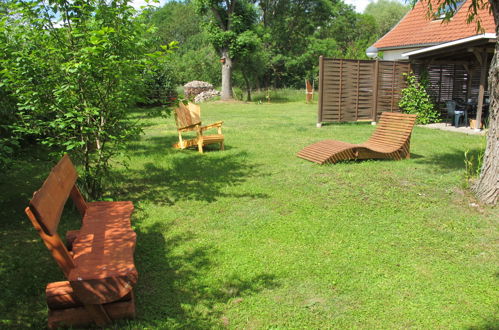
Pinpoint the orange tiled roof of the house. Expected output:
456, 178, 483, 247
374, 0, 495, 49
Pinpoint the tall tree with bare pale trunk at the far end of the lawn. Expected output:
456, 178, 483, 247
196, 0, 257, 100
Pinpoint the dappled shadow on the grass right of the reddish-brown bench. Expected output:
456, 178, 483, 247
127, 220, 278, 329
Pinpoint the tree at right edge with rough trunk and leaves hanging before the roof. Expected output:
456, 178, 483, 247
423, 0, 499, 204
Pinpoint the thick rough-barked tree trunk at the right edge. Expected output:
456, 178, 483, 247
473, 0, 499, 204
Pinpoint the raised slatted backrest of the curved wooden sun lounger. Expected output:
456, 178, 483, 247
368, 112, 417, 146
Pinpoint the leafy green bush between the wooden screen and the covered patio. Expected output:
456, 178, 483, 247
399, 72, 440, 125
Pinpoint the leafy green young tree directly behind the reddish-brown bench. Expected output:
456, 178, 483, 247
0, 0, 173, 198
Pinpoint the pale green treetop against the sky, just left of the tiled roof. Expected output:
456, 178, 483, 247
364, 0, 410, 36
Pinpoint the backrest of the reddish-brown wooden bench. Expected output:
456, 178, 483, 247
25, 155, 86, 276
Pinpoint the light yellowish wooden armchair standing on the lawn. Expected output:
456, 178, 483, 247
173, 102, 224, 153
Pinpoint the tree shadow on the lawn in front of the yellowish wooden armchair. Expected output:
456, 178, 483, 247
113, 138, 268, 205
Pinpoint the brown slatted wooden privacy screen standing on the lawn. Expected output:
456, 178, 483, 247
317, 56, 410, 123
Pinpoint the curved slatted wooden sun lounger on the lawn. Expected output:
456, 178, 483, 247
297, 112, 416, 164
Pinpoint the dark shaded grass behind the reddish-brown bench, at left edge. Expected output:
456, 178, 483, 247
0, 152, 82, 328
